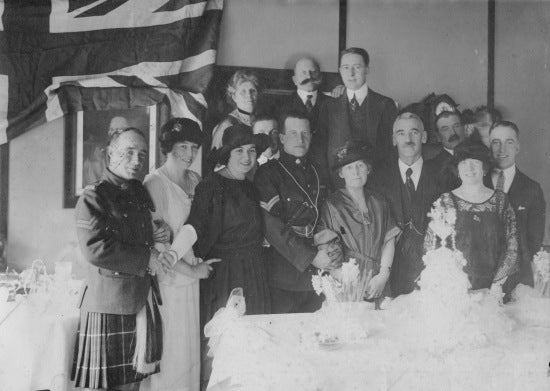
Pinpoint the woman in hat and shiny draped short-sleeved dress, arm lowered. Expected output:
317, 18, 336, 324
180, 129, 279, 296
319, 142, 401, 298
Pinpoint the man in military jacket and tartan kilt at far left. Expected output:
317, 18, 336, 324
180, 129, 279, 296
72, 128, 169, 390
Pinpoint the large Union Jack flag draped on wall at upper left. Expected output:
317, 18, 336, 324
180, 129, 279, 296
0, 0, 223, 144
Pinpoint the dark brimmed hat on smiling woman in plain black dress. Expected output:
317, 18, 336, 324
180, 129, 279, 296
213, 124, 272, 164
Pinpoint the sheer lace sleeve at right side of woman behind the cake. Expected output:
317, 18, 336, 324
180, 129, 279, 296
494, 197, 519, 281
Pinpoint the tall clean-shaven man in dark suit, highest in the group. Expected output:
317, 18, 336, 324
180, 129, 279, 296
319, 48, 397, 186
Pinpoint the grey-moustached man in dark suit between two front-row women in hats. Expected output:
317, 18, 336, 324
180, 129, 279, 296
369, 112, 441, 296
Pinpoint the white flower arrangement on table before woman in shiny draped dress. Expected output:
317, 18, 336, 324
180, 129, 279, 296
311, 258, 372, 304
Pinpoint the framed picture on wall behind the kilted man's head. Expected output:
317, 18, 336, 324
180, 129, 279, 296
63, 105, 166, 208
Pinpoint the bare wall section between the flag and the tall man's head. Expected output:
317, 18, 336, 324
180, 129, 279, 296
217, 0, 339, 72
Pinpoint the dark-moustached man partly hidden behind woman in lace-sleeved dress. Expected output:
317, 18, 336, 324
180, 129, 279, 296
431, 111, 465, 192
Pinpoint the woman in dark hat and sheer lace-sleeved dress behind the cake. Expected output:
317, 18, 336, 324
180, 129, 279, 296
424, 140, 519, 296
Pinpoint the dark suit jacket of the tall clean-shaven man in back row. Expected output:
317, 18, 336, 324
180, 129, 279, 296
319, 88, 397, 182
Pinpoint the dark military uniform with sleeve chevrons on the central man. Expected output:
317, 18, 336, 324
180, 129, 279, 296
254, 152, 324, 291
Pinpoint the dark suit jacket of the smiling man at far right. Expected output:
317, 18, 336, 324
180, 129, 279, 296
485, 169, 546, 286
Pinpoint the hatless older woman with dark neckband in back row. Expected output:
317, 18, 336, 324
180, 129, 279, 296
212, 71, 260, 149
